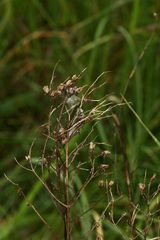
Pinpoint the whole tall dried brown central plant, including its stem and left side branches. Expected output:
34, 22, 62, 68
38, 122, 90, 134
6, 71, 119, 240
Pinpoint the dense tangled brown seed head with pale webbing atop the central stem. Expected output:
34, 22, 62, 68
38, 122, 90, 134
43, 70, 113, 147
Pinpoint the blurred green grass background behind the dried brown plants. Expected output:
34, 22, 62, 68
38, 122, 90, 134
0, 0, 160, 240
